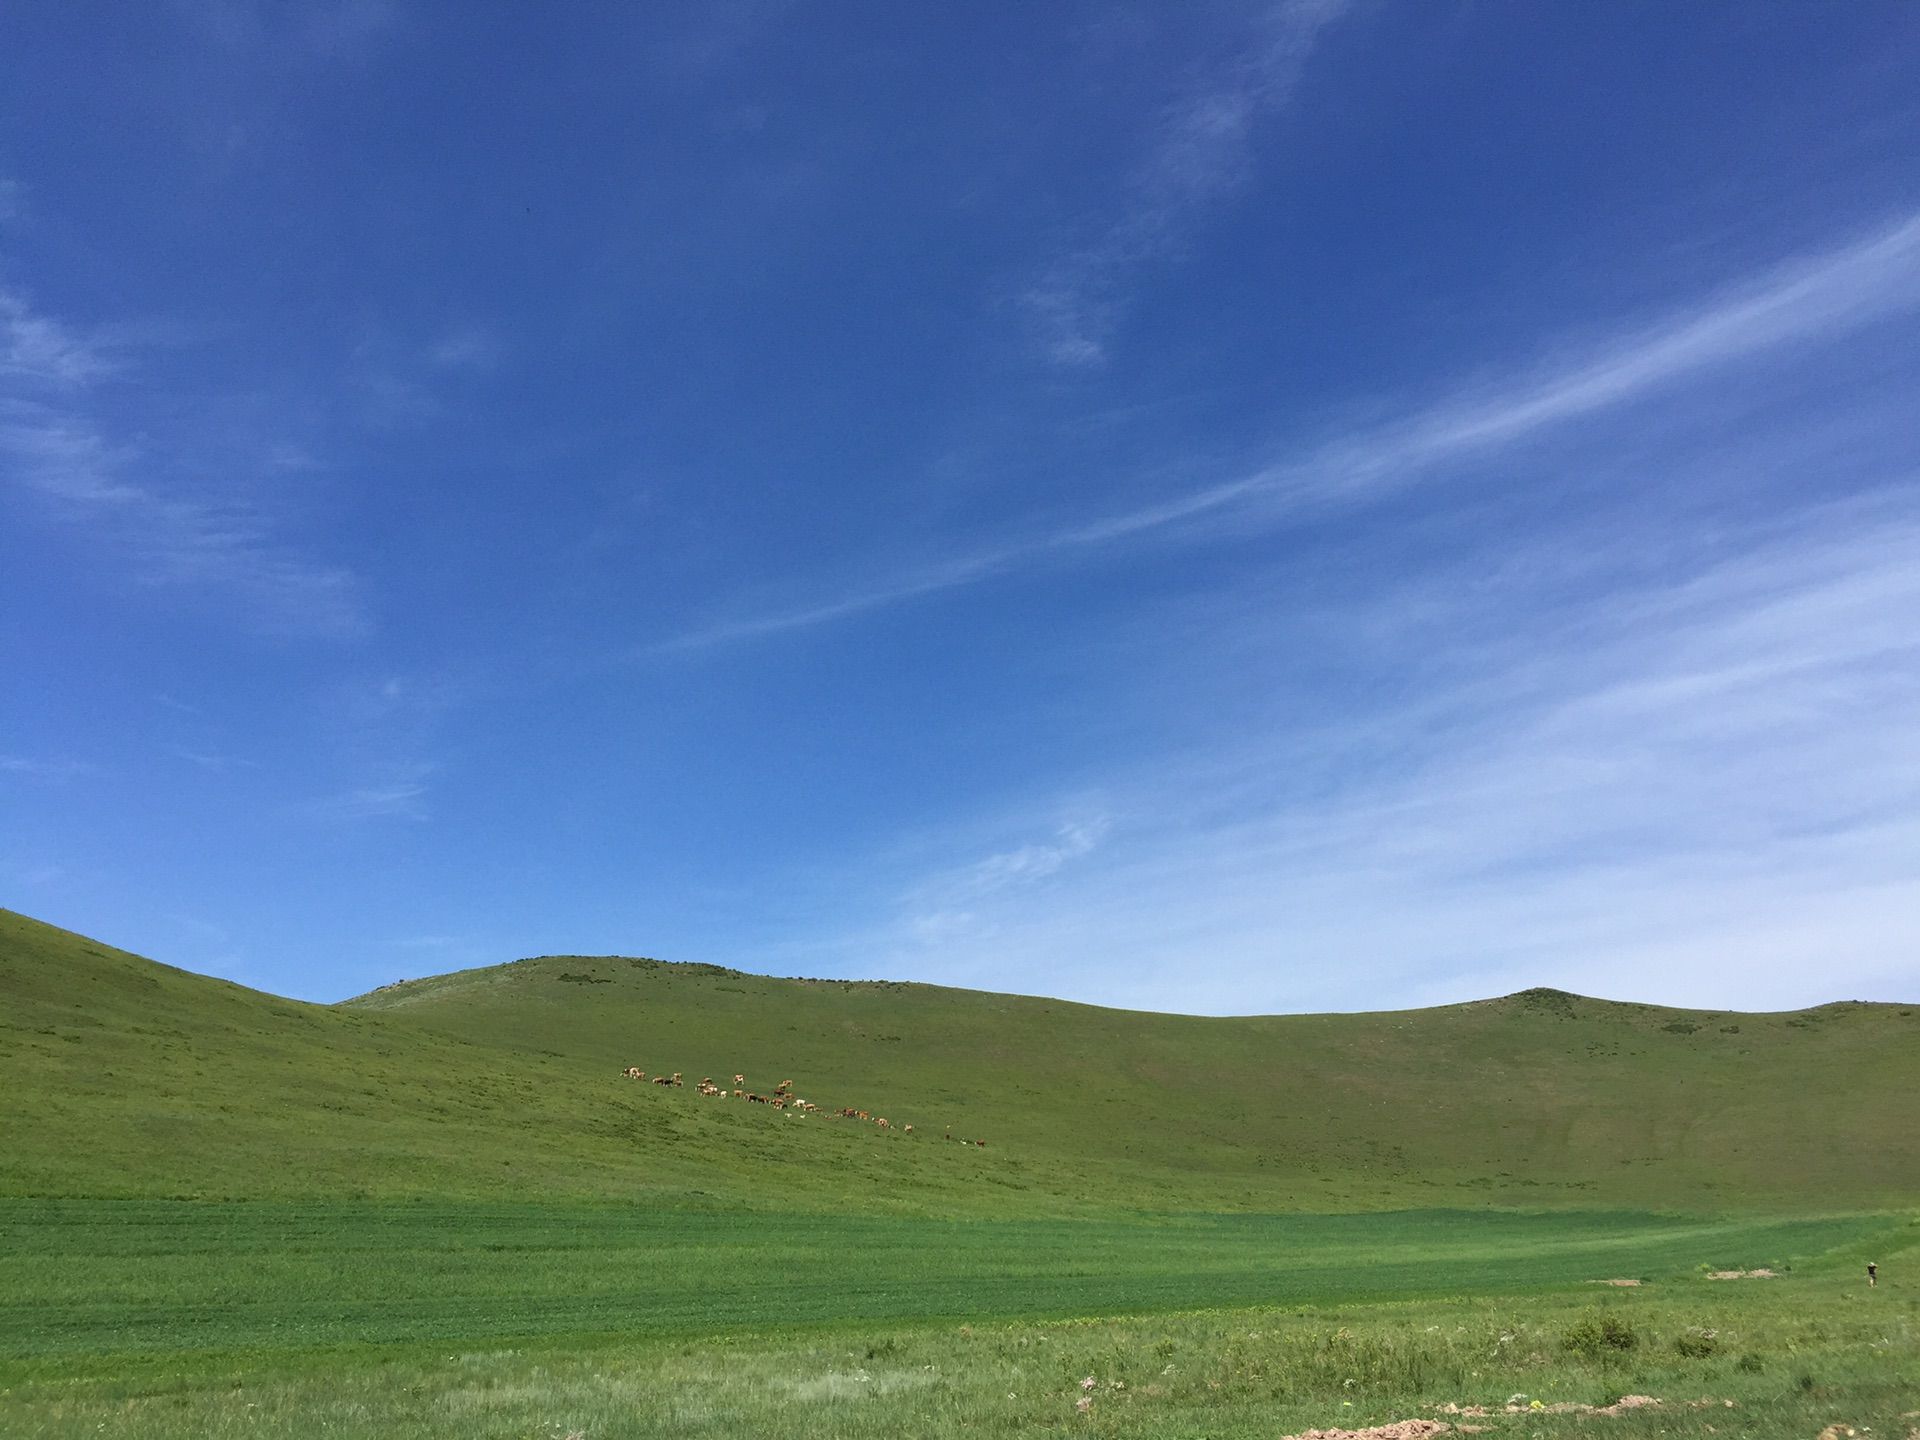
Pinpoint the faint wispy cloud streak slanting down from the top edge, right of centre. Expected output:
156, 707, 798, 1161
1021, 0, 1348, 367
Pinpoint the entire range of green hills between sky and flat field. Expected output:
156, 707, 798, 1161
0, 910, 1920, 1215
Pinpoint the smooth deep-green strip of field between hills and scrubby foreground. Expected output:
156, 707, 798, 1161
0, 1200, 1887, 1359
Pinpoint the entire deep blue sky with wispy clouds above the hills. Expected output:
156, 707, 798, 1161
0, 0, 1920, 1012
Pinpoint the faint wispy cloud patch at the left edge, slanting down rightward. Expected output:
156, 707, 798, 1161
0, 290, 367, 636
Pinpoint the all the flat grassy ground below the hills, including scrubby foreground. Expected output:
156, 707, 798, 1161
0, 1202, 1920, 1440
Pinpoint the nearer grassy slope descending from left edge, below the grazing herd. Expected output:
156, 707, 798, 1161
0, 910, 1021, 1212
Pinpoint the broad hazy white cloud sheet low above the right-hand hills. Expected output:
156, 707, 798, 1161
864, 488, 1920, 1012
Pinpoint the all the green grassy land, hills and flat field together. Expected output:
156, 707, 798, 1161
0, 912, 1920, 1440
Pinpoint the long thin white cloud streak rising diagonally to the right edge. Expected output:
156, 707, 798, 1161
655, 215, 1920, 651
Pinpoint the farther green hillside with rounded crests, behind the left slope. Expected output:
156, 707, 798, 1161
348, 956, 1920, 1208
